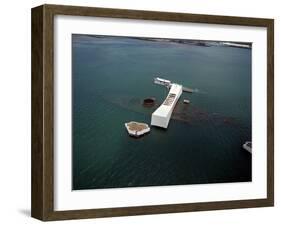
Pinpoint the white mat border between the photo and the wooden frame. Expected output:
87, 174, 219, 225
54, 15, 267, 211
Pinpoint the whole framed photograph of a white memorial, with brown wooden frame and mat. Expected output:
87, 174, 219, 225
32, 5, 274, 221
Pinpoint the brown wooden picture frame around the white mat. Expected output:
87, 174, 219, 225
31, 5, 274, 221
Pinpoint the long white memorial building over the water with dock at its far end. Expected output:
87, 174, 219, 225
151, 83, 183, 129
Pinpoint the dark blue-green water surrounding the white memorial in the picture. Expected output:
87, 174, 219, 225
72, 34, 252, 190
